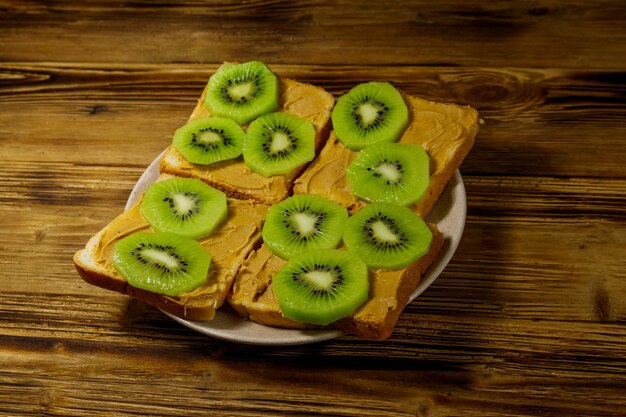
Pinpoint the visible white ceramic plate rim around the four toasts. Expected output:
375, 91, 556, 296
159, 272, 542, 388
126, 150, 467, 346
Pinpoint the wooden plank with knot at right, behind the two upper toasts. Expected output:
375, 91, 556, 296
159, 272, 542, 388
0, 63, 626, 178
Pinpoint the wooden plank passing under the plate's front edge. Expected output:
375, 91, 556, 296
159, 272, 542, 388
0, 290, 626, 372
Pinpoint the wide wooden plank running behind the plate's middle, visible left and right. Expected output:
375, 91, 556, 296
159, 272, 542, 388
0, 162, 626, 322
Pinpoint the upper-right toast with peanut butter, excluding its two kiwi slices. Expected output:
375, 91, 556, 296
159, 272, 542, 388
294, 96, 478, 217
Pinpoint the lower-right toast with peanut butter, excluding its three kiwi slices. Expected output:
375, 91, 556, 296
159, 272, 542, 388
228, 224, 444, 340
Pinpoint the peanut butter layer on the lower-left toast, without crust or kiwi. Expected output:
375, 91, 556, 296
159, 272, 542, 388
90, 189, 267, 308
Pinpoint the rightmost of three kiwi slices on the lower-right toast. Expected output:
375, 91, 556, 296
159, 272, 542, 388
343, 203, 433, 269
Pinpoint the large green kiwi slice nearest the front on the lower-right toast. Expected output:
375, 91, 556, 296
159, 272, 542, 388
272, 249, 369, 325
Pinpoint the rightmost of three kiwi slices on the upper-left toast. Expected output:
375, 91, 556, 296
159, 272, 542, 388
243, 113, 315, 177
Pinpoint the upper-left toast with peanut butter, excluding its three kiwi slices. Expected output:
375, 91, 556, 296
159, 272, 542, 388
160, 78, 335, 205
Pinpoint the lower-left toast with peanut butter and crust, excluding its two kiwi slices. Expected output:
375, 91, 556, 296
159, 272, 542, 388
74, 175, 267, 320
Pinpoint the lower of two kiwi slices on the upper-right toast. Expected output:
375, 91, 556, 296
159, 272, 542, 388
346, 142, 430, 206
